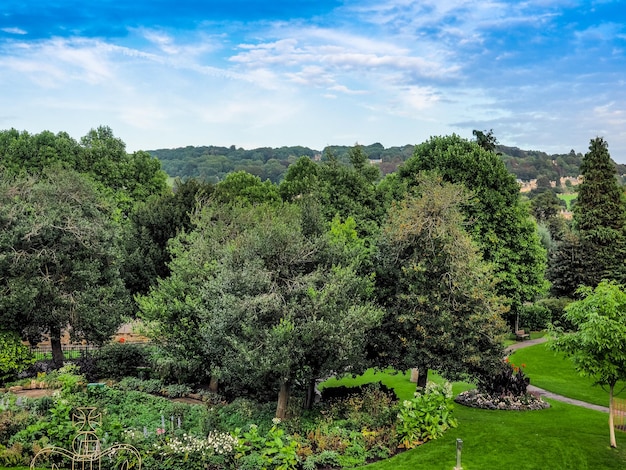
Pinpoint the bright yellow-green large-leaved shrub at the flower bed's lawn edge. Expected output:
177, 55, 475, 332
396, 382, 457, 449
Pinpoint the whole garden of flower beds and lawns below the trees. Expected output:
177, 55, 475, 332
0, 332, 626, 470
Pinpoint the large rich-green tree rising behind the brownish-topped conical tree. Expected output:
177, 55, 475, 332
398, 135, 548, 322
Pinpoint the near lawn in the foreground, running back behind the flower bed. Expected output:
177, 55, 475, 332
324, 370, 626, 470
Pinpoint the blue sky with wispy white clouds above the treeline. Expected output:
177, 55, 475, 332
0, 0, 626, 163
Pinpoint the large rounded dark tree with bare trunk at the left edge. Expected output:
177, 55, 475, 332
0, 167, 129, 365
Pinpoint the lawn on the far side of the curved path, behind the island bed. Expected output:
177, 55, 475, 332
510, 343, 626, 406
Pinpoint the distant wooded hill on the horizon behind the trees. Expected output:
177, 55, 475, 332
148, 143, 626, 183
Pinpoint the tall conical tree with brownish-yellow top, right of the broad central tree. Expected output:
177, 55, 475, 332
368, 177, 506, 386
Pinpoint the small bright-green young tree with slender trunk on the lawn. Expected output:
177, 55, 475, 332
551, 281, 626, 447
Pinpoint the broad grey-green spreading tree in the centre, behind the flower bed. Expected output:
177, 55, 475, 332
140, 204, 380, 418
